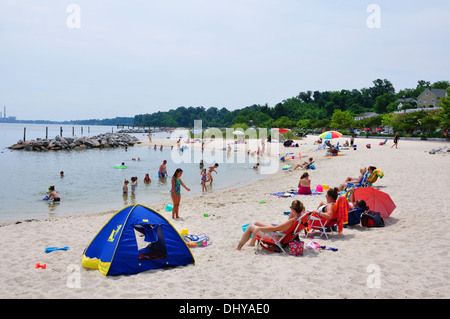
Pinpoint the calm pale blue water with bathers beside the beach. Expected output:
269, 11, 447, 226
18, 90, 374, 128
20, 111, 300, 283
0, 123, 263, 222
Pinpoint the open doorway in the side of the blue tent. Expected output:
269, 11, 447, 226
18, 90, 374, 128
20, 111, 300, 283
133, 224, 167, 260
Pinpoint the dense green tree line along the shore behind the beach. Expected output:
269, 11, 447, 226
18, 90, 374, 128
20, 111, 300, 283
133, 79, 450, 133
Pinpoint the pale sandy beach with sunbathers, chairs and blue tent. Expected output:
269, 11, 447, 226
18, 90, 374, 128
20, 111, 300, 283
0, 136, 450, 299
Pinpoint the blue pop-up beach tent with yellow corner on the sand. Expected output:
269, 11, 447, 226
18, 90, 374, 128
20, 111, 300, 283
81, 204, 195, 276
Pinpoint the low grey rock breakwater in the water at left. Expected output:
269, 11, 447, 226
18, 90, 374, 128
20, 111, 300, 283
8, 133, 141, 151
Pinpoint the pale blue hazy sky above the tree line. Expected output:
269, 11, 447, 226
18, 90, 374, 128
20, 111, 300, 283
0, 0, 450, 121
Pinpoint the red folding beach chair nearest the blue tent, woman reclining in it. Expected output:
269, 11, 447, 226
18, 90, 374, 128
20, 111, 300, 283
255, 214, 308, 255
